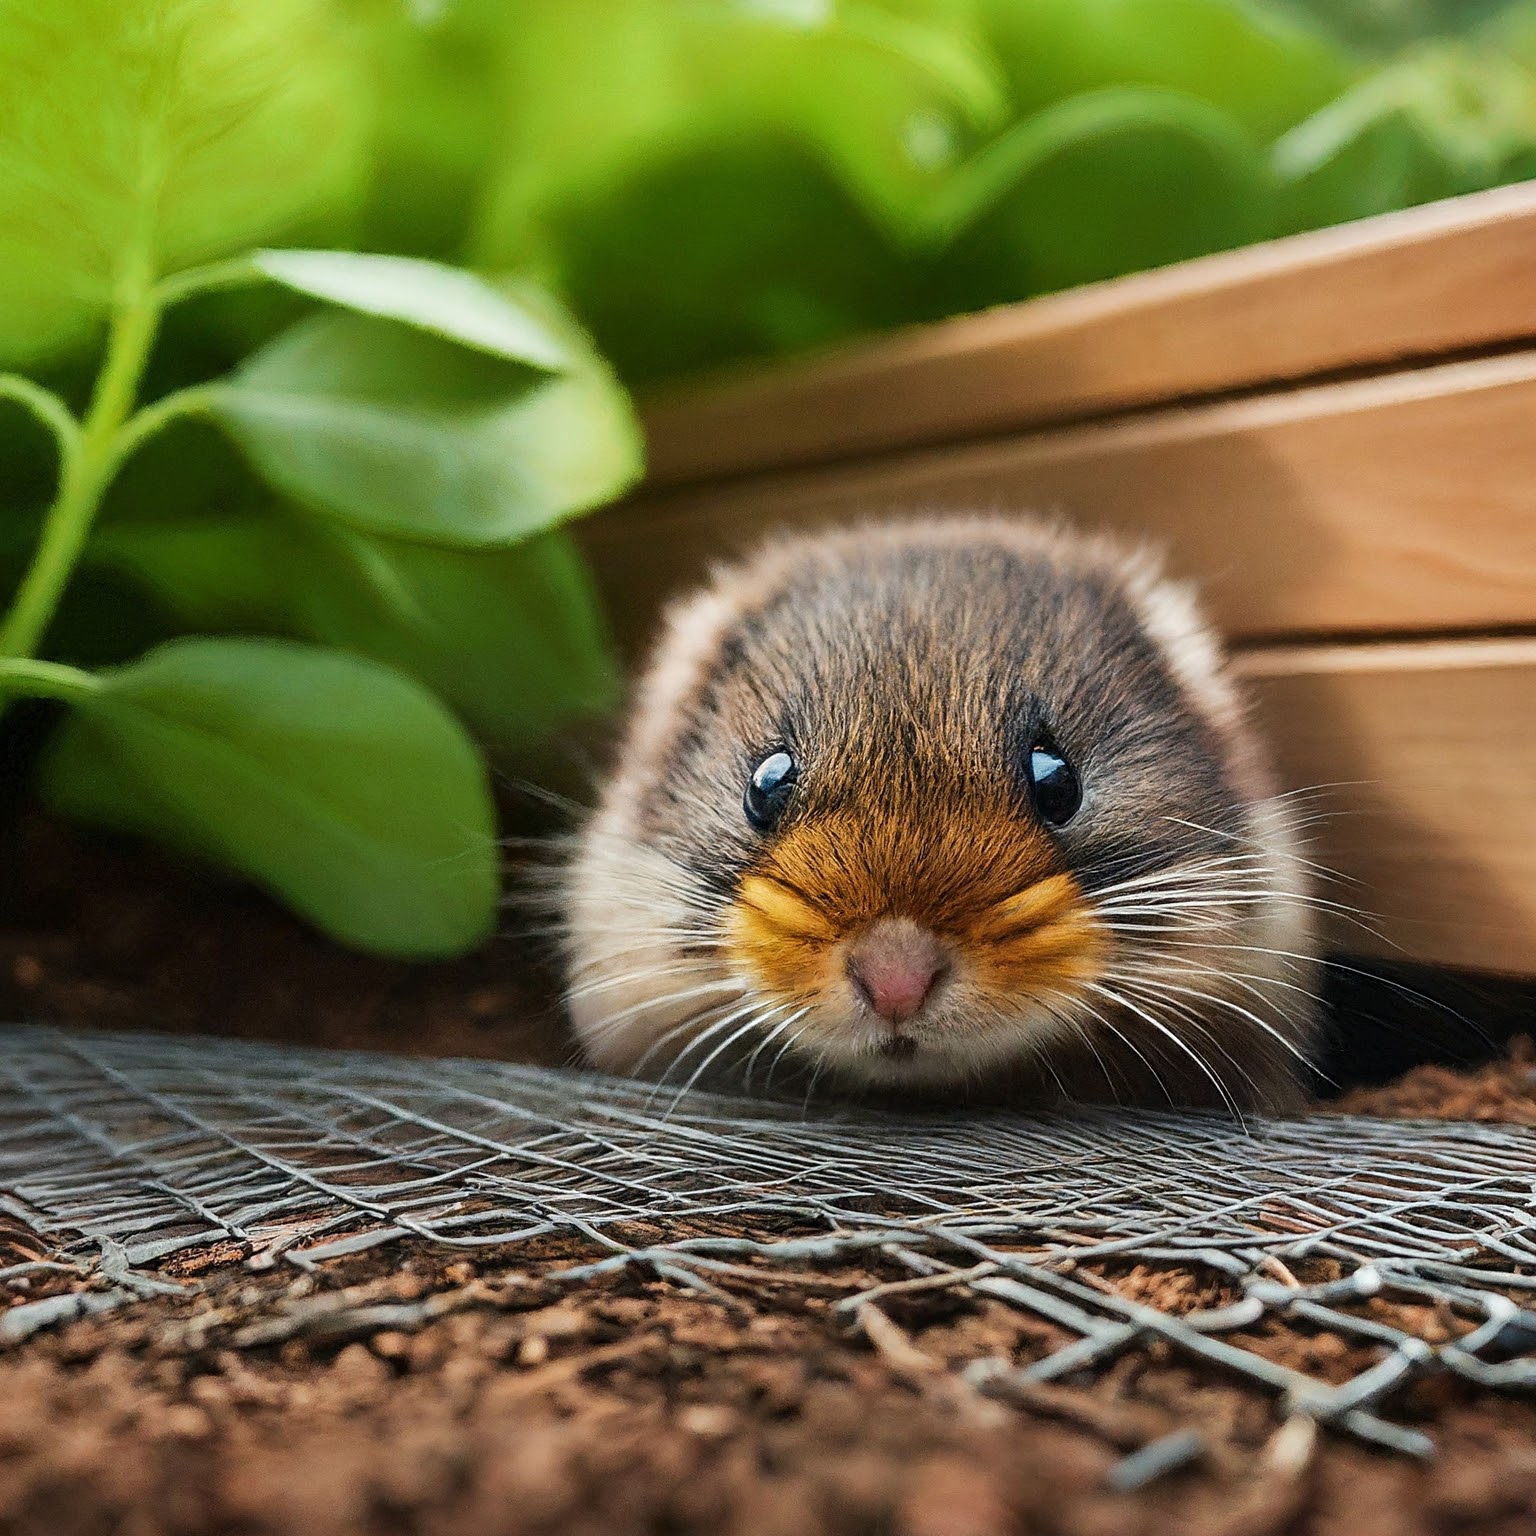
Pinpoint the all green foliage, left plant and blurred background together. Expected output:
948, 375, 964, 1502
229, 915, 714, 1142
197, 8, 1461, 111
0, 0, 1536, 954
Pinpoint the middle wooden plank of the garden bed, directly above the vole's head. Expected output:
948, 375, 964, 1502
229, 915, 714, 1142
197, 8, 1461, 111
581, 352, 1536, 645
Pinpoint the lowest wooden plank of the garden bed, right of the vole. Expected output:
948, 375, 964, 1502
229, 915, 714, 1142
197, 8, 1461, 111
1240, 639, 1536, 975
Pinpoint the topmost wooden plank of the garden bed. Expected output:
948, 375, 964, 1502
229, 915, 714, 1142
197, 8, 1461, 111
645, 181, 1536, 484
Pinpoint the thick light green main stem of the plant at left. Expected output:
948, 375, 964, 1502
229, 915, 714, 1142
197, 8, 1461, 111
0, 284, 160, 657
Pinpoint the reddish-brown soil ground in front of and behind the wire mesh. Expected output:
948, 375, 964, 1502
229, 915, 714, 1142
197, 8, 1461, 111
0, 826, 1536, 1536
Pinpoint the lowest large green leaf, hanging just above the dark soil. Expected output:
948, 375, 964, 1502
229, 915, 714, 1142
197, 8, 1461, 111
45, 639, 499, 958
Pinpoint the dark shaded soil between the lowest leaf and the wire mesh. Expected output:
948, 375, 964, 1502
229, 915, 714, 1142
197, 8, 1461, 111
0, 820, 570, 1064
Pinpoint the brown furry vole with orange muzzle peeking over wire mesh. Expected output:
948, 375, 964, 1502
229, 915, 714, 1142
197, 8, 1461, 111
562, 518, 1316, 1112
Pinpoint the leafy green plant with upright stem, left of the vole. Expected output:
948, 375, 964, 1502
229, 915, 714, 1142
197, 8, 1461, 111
0, 0, 639, 957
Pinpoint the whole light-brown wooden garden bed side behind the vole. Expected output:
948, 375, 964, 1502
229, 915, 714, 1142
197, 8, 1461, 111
584, 183, 1536, 974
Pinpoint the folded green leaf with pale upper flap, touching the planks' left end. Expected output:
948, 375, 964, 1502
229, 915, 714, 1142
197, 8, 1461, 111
212, 270, 642, 545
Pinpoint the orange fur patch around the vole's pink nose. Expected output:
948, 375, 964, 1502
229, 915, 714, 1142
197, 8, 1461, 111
727, 817, 1107, 1006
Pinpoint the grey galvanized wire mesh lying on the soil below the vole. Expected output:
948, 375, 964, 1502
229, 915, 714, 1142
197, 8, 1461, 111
0, 1028, 1536, 1453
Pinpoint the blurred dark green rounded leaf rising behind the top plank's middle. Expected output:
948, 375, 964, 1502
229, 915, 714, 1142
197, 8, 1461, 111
935, 86, 1269, 309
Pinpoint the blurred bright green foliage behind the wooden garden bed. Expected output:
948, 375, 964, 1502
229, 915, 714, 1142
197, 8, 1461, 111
405, 0, 1536, 384
